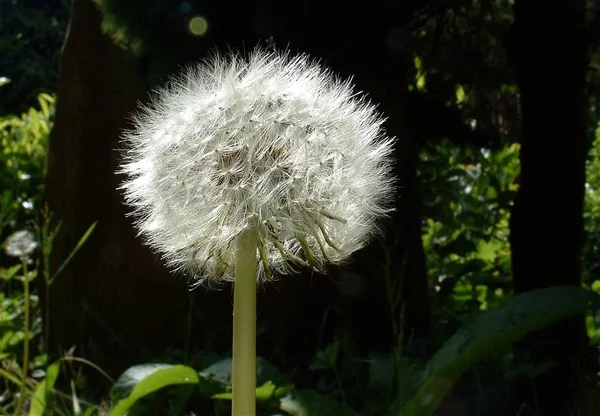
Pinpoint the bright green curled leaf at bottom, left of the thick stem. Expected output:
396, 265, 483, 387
110, 364, 199, 416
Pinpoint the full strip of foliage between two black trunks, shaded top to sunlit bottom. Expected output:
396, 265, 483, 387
409, 0, 520, 331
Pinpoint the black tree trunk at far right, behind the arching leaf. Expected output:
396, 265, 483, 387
510, 0, 588, 415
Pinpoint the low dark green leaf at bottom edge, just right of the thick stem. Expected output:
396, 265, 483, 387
279, 390, 358, 416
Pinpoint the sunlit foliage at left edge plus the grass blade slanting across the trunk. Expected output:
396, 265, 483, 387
0, 94, 95, 415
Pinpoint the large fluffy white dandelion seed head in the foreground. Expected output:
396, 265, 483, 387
120, 49, 394, 283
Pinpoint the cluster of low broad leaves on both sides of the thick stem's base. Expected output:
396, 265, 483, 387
110, 358, 357, 416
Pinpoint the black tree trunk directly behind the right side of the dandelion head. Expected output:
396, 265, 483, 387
258, 1, 429, 358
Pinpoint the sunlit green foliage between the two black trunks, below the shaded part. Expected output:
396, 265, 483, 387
418, 141, 519, 321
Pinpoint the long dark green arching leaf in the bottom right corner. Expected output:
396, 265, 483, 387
402, 286, 600, 416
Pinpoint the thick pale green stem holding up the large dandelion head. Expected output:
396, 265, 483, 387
232, 227, 258, 416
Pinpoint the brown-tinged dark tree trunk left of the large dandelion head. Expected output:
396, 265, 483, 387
42, 0, 230, 371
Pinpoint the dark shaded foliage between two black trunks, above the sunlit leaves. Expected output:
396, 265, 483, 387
409, 0, 520, 147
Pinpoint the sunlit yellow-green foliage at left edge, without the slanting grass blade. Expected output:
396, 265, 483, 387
0, 94, 54, 414
